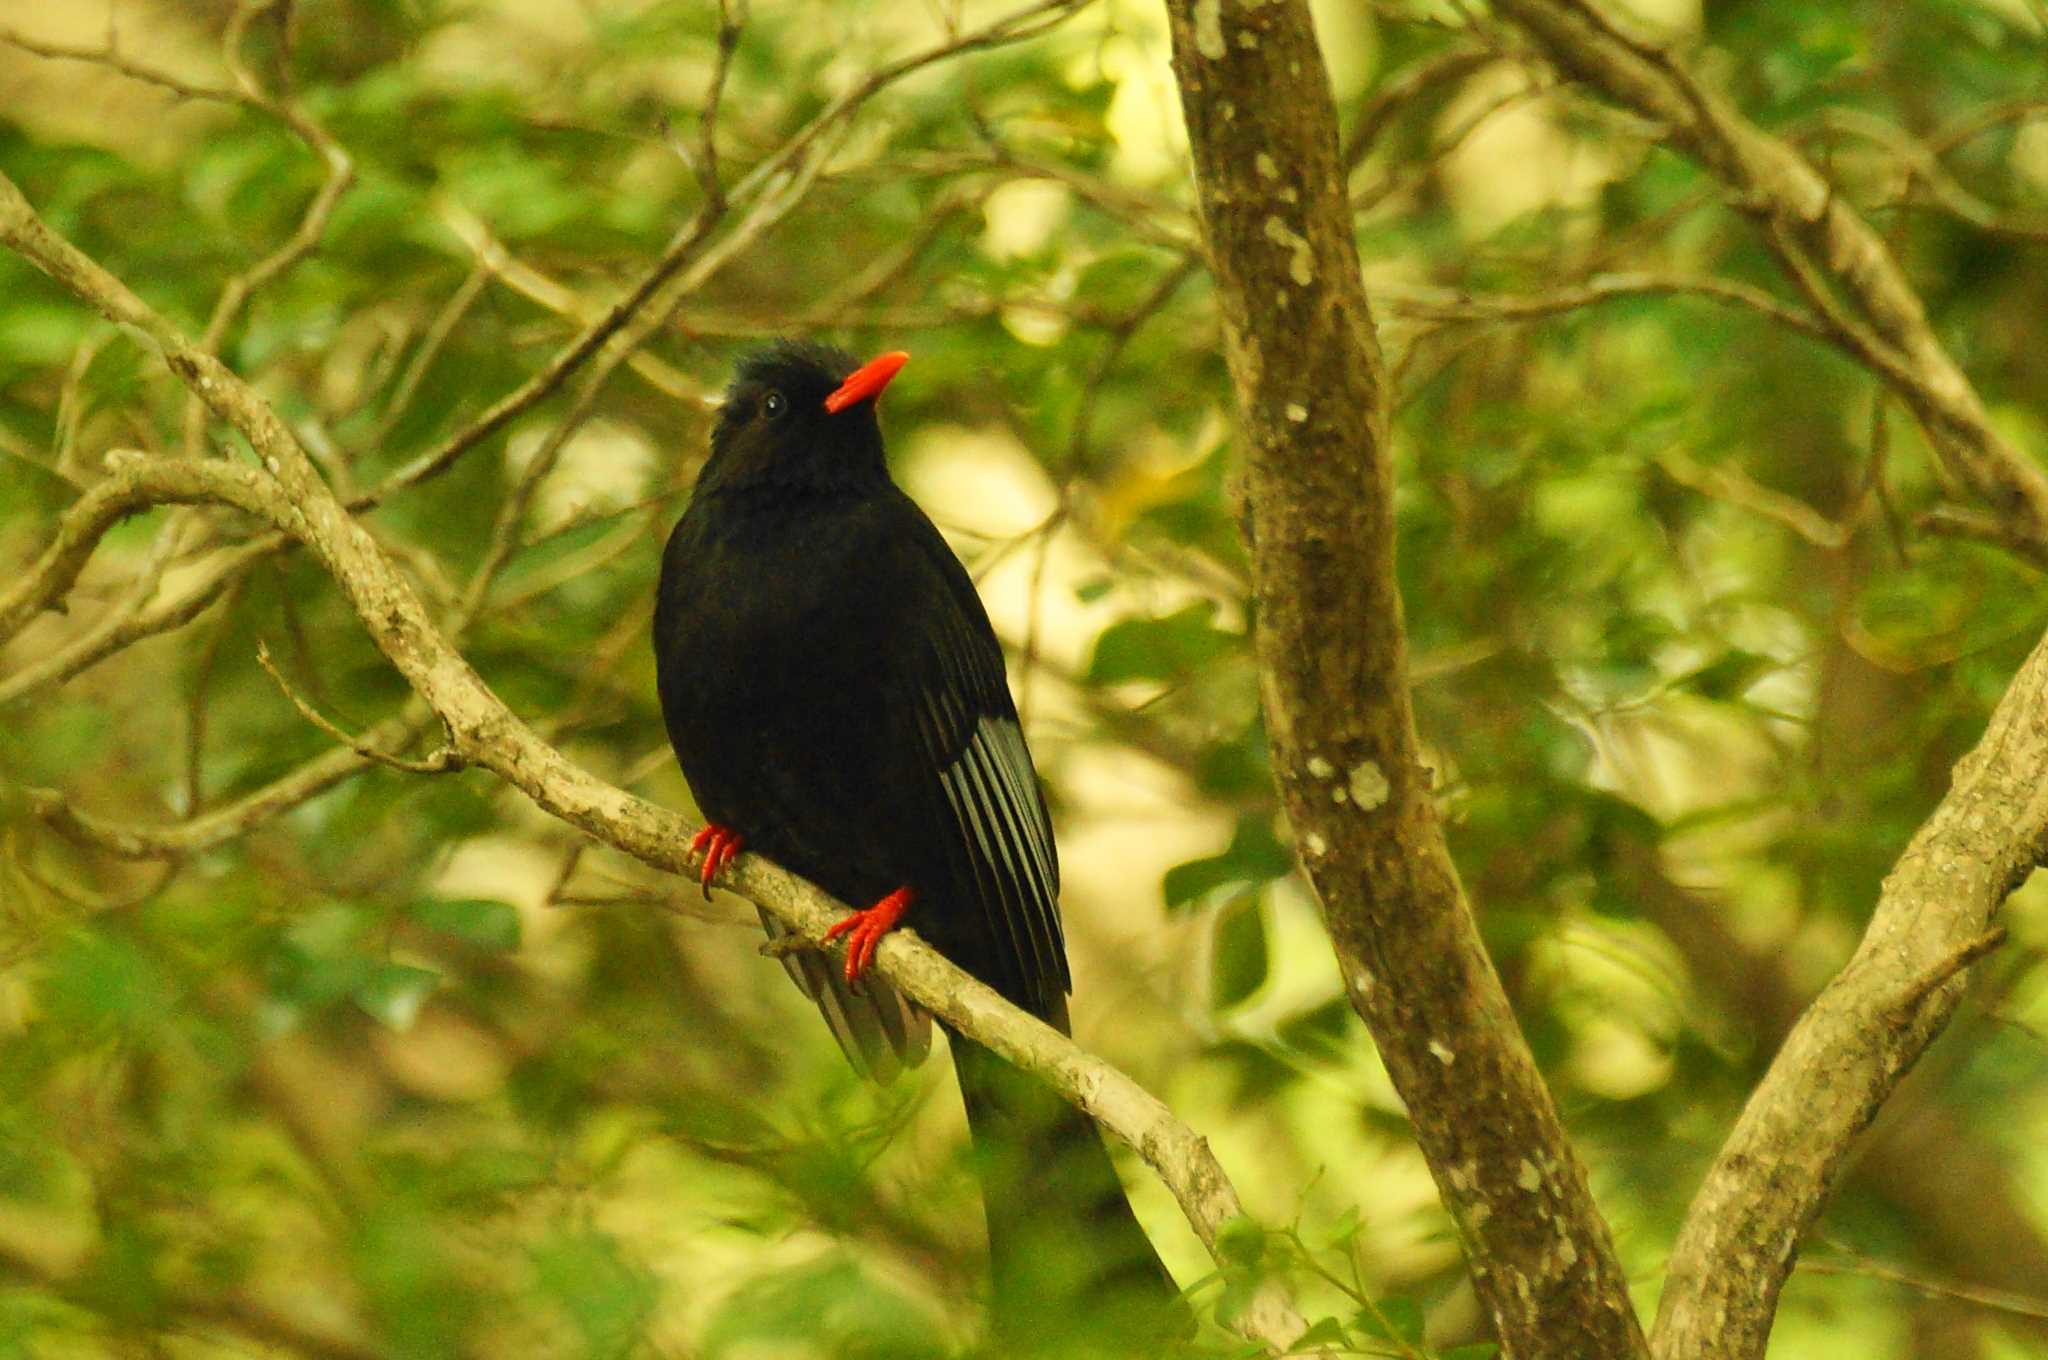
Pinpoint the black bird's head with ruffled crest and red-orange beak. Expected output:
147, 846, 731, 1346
705, 340, 909, 490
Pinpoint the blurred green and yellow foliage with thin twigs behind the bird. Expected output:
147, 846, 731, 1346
0, 0, 2048, 1360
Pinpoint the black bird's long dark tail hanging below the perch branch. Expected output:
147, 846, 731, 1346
948, 1032, 1194, 1356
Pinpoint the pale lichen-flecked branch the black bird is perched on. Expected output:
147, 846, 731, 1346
0, 164, 1307, 1350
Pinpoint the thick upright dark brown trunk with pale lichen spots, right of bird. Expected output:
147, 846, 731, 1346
1167, 0, 1645, 1360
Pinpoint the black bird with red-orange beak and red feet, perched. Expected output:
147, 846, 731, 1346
653, 340, 1190, 1354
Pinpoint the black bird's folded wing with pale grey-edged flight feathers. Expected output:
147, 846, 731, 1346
899, 503, 1071, 1024
